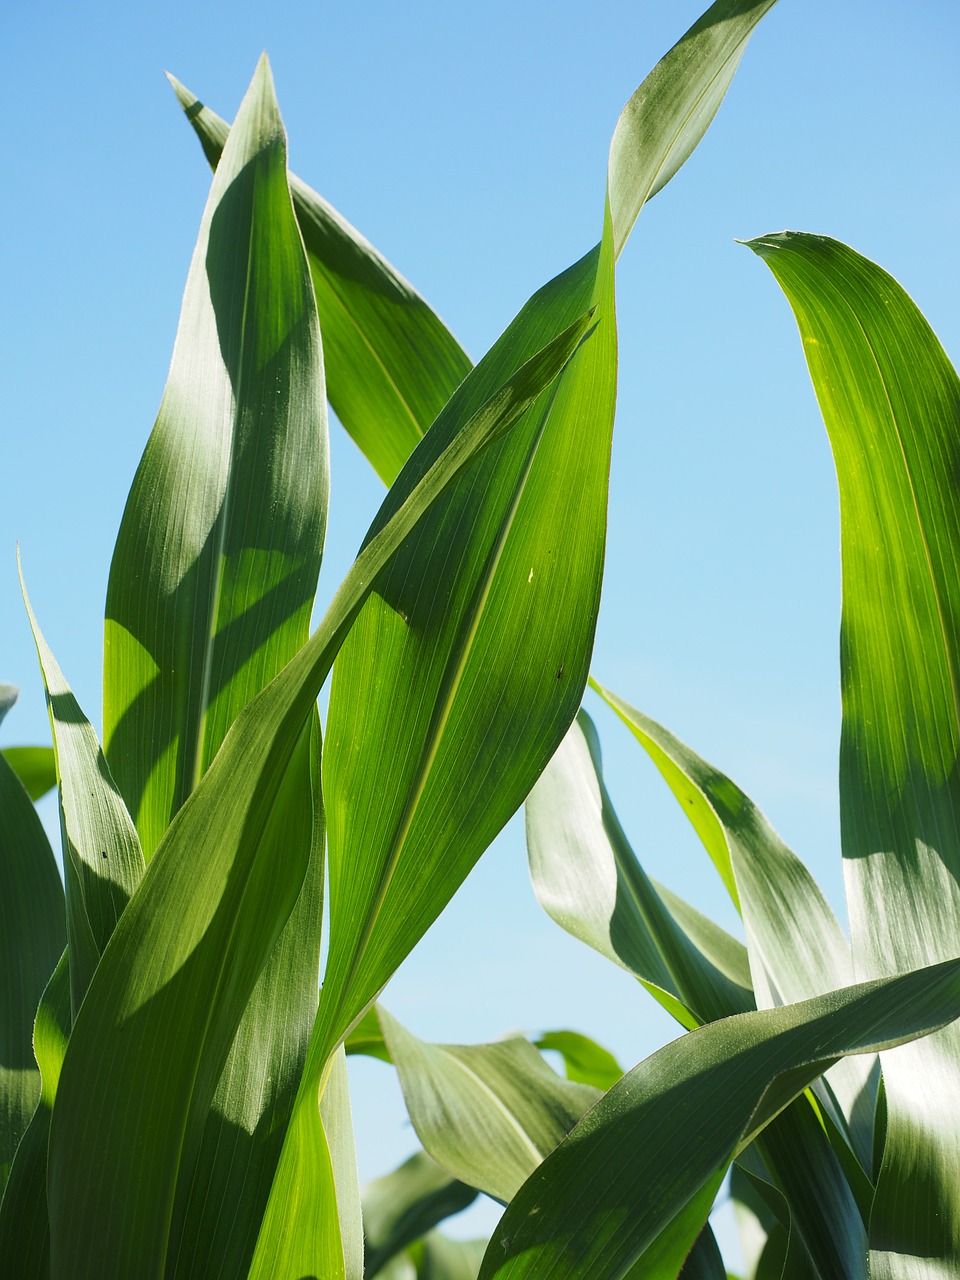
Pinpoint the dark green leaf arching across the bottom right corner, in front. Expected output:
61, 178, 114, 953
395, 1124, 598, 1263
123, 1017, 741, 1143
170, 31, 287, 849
480, 960, 960, 1280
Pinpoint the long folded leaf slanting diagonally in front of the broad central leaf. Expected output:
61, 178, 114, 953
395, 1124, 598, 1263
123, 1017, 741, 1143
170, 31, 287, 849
49, 241, 599, 1280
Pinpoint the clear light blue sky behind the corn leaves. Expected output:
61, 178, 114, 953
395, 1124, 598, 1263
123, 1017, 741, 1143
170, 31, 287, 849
0, 0, 960, 1259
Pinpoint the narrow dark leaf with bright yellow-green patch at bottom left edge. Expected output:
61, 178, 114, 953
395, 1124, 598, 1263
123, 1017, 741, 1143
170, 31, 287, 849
0, 951, 72, 1280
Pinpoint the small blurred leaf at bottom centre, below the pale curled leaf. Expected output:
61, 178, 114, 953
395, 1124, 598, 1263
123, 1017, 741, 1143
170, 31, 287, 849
361, 1151, 483, 1280
